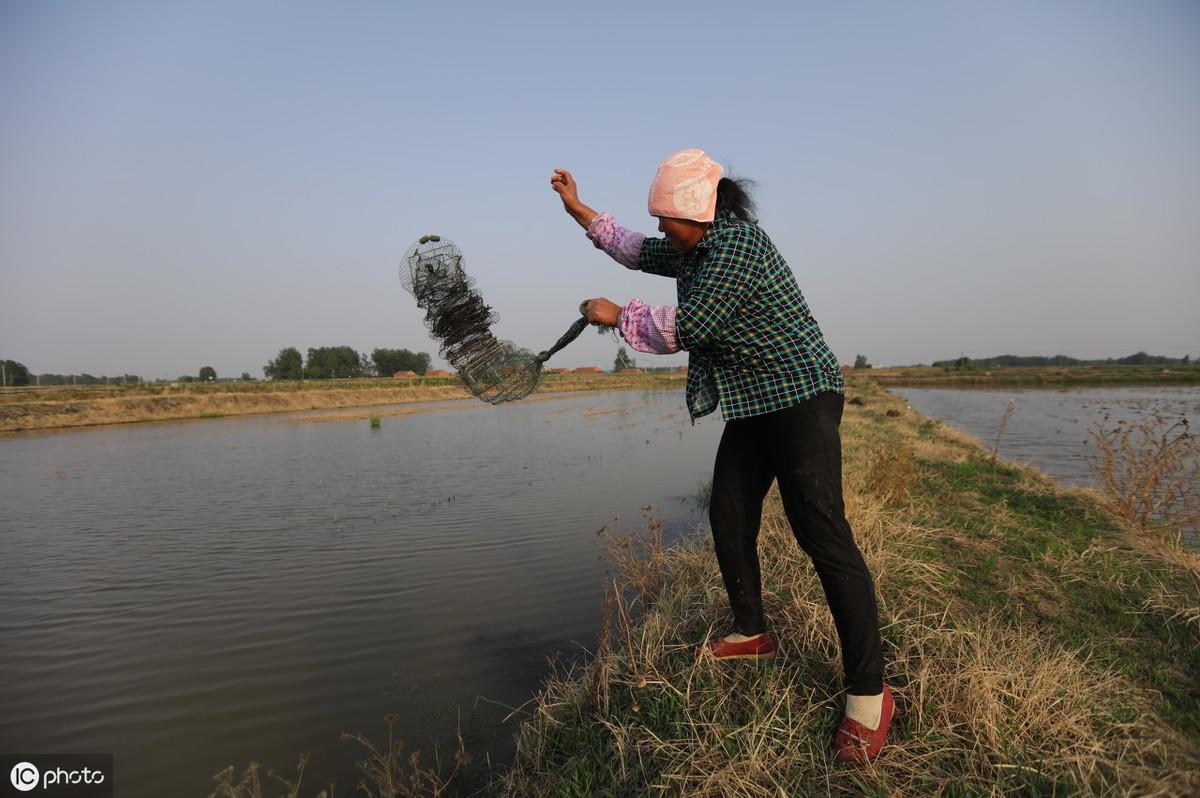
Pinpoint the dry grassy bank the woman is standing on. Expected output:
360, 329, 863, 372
503, 380, 1200, 797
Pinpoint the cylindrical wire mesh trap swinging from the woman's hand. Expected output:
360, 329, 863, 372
400, 235, 588, 404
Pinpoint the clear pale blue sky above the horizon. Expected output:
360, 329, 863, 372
0, 0, 1200, 378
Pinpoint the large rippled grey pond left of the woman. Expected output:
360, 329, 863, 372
0, 391, 722, 798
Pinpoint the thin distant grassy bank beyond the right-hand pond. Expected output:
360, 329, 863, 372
854, 366, 1200, 388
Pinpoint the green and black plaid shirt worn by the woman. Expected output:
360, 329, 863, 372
637, 215, 845, 421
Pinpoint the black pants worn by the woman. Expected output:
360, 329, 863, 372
709, 392, 883, 695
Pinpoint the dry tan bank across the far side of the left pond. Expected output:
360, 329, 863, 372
0, 373, 684, 432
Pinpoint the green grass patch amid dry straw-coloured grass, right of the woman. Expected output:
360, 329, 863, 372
918, 455, 1200, 739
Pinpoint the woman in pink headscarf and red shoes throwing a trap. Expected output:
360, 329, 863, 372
550, 150, 893, 763
